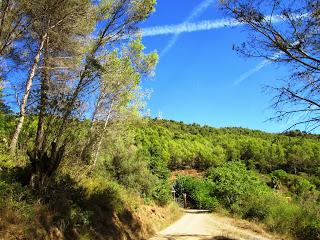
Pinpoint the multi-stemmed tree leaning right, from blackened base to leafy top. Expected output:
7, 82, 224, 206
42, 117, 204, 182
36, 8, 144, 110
29, 0, 155, 188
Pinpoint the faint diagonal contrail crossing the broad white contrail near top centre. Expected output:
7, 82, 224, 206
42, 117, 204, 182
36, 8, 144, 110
161, 0, 213, 56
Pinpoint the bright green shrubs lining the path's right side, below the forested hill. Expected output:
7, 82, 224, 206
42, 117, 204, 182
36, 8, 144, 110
207, 162, 320, 239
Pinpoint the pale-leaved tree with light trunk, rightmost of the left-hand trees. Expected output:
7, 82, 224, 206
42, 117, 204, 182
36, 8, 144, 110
83, 38, 158, 165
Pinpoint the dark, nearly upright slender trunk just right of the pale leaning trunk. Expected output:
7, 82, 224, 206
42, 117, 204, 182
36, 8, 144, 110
35, 37, 49, 151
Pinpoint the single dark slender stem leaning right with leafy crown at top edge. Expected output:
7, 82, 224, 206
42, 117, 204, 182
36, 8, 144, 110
55, 0, 155, 142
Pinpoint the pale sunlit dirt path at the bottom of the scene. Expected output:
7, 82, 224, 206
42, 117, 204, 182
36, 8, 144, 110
150, 211, 274, 240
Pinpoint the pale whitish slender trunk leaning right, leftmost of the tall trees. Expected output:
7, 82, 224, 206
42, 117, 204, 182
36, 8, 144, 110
10, 34, 47, 154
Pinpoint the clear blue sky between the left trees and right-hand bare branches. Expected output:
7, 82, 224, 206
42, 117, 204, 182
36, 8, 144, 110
141, 0, 290, 132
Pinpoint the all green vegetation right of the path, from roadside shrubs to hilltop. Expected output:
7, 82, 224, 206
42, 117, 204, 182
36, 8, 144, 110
136, 120, 320, 239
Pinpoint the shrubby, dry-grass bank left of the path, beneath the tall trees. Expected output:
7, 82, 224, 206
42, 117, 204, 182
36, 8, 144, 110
0, 114, 179, 239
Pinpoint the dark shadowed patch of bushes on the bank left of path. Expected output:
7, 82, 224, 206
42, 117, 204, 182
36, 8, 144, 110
39, 176, 148, 239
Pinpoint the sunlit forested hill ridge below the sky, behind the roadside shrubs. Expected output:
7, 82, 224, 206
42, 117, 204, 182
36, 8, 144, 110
136, 119, 320, 178
